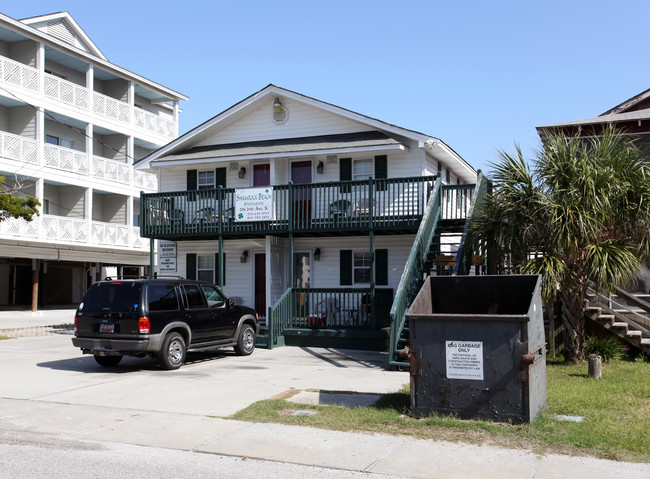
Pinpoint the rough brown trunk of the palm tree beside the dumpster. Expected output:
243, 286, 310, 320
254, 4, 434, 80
558, 285, 587, 363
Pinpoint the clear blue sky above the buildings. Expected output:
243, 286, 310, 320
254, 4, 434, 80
5, 0, 650, 171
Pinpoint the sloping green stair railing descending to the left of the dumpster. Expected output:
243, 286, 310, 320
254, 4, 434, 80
388, 178, 442, 365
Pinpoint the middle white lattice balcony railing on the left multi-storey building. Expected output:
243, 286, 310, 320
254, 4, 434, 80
0, 133, 158, 191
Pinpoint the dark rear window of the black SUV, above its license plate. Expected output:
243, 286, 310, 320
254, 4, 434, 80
79, 282, 142, 313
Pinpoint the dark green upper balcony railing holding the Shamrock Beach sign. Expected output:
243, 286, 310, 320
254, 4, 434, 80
140, 176, 474, 241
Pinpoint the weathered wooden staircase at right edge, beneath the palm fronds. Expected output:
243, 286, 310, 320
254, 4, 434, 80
584, 289, 650, 354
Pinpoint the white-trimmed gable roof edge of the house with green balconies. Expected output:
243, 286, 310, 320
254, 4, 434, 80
138, 84, 476, 177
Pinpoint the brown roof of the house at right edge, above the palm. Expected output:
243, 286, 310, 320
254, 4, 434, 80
537, 90, 650, 149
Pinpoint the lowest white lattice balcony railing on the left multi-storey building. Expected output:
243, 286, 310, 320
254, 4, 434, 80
0, 214, 149, 251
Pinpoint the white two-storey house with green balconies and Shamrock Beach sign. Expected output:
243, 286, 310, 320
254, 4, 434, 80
136, 85, 477, 347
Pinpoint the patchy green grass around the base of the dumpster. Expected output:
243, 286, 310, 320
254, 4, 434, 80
232, 360, 650, 462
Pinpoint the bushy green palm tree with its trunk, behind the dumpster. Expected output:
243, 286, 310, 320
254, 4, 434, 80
474, 128, 650, 362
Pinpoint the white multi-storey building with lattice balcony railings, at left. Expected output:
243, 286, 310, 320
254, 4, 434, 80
0, 12, 187, 305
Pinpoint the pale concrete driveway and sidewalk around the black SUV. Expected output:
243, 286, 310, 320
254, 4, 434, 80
0, 310, 650, 479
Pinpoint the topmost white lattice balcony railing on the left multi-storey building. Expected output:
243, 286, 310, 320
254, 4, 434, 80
0, 56, 176, 140
